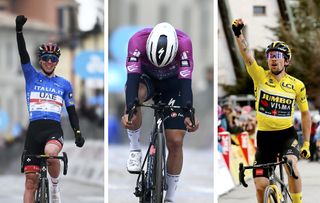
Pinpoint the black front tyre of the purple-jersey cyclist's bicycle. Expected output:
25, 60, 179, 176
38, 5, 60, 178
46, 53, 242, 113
152, 133, 164, 203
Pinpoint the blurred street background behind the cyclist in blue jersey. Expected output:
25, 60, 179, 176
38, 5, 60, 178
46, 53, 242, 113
0, 0, 104, 174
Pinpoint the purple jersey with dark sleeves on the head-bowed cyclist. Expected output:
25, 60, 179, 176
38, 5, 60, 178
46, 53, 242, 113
125, 28, 193, 109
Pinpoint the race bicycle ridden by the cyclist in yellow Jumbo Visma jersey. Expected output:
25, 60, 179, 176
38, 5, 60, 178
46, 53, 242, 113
239, 156, 298, 203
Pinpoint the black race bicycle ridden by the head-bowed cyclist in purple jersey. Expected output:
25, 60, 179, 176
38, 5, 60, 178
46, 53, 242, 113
128, 102, 195, 203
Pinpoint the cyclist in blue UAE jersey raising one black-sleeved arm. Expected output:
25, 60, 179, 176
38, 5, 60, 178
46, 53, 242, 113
16, 15, 85, 203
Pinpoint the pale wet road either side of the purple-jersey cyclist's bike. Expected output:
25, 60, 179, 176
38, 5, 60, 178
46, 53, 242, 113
108, 145, 213, 203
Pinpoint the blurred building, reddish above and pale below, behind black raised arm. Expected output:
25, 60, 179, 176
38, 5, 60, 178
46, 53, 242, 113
0, 0, 77, 137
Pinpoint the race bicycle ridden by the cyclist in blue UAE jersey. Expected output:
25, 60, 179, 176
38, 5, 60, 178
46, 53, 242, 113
21, 152, 68, 203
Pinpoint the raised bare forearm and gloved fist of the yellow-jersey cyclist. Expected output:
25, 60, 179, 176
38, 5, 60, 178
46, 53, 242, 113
232, 18, 255, 65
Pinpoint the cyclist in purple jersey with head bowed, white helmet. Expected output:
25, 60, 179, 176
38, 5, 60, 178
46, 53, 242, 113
122, 23, 199, 202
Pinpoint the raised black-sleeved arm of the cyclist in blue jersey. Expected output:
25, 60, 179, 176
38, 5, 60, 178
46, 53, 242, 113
16, 15, 30, 64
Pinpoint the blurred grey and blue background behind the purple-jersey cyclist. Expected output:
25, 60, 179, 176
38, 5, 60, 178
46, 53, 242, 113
108, 0, 213, 147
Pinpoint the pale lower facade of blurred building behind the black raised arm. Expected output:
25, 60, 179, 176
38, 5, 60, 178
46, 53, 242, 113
0, 13, 56, 130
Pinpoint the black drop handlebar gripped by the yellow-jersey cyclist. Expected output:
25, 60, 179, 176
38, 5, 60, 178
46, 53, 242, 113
239, 156, 299, 187
